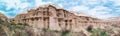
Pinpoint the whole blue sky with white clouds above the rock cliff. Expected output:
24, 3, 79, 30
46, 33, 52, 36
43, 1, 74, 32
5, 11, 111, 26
0, 0, 120, 19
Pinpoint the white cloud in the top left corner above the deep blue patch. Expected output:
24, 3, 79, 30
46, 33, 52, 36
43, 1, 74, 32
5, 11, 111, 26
1, 0, 32, 10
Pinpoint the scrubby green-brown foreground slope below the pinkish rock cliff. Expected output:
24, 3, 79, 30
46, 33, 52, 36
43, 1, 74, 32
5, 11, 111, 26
0, 3, 120, 36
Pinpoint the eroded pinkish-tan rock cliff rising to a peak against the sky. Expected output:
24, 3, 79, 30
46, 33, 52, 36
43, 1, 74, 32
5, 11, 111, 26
6, 4, 120, 36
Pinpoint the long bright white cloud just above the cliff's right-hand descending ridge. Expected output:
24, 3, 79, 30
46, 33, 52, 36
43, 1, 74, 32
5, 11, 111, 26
70, 5, 113, 19
